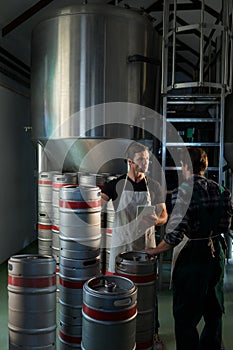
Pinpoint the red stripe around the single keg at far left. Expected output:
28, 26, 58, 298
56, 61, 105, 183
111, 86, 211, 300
8, 276, 56, 288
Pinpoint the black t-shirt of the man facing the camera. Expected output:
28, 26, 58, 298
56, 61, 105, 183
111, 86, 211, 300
102, 174, 165, 210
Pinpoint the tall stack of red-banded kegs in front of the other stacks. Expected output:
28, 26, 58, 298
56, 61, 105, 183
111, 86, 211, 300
59, 185, 101, 350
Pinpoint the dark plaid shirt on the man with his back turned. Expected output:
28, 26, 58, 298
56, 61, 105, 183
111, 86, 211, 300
164, 175, 233, 246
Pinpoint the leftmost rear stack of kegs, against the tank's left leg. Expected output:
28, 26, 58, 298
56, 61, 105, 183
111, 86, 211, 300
37, 171, 53, 255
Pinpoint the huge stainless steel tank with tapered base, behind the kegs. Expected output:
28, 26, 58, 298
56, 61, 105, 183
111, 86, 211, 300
31, 4, 161, 173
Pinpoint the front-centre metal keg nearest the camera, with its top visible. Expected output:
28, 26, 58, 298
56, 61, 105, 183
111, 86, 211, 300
81, 276, 137, 350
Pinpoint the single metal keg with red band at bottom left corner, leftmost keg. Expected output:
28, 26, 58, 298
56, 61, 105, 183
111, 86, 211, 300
8, 255, 56, 350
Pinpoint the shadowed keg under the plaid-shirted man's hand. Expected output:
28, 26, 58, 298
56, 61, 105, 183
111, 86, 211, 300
115, 251, 156, 350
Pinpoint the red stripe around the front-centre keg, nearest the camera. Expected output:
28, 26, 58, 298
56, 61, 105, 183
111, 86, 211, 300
82, 304, 137, 321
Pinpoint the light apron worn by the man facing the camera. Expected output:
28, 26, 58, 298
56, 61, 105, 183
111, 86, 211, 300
108, 176, 156, 272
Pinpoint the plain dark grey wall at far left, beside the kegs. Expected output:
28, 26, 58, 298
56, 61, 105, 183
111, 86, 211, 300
0, 81, 37, 263
